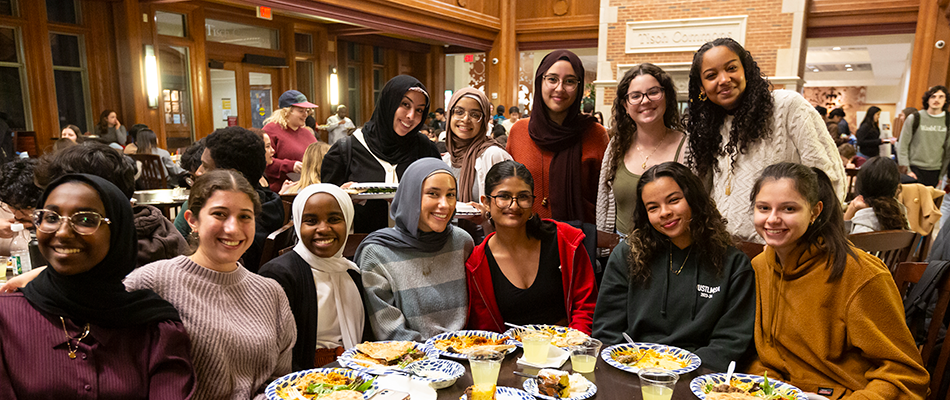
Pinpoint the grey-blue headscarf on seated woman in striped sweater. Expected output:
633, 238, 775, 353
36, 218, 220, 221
353, 157, 458, 262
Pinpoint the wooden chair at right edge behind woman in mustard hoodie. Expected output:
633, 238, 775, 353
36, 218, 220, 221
894, 262, 950, 400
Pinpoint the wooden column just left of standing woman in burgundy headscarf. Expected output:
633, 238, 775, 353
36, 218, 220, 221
485, 0, 520, 111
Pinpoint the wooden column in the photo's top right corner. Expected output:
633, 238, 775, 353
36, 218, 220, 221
907, 0, 950, 109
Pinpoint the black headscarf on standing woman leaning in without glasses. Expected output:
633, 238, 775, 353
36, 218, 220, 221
361, 75, 432, 165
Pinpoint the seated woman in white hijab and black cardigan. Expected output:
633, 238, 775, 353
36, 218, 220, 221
260, 183, 380, 371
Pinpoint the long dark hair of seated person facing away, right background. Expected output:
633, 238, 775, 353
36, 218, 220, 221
855, 157, 910, 230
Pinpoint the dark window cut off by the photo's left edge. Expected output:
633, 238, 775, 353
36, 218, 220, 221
0, 27, 30, 130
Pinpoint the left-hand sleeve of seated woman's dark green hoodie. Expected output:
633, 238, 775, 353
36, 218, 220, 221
593, 242, 630, 345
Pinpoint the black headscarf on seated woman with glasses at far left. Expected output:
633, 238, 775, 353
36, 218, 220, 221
21, 174, 181, 328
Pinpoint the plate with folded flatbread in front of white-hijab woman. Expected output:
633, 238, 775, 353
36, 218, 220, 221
339, 340, 438, 375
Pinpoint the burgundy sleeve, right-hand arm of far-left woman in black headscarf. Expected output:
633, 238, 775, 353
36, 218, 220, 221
148, 321, 197, 400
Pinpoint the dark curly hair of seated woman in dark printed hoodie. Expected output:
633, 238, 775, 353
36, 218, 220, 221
626, 161, 733, 285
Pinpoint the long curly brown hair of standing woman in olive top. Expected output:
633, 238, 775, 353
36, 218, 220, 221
607, 63, 683, 182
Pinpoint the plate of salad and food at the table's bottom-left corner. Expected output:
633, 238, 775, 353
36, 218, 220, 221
264, 368, 373, 400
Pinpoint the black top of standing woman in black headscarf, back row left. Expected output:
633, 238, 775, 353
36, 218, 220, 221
320, 133, 441, 233
